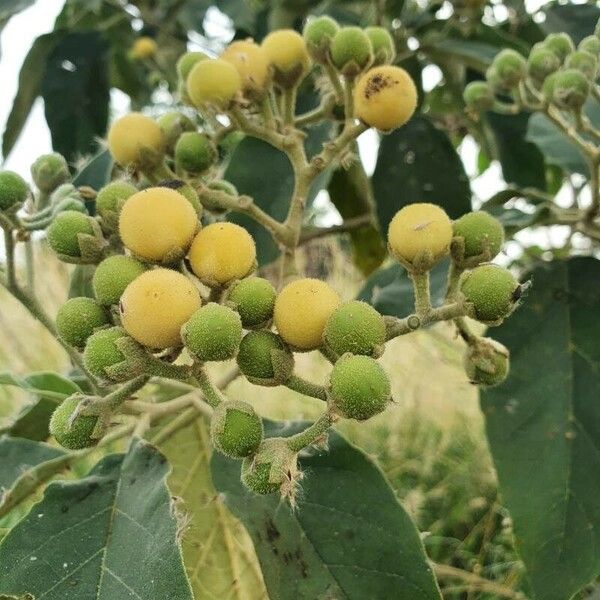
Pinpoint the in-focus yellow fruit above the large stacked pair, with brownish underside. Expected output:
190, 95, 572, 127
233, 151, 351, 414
108, 113, 165, 166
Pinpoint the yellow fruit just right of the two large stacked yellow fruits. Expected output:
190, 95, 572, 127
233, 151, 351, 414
189, 223, 256, 285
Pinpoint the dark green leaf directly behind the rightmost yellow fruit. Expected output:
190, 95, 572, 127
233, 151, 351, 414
372, 116, 471, 233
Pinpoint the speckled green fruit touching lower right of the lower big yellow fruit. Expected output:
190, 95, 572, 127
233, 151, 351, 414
181, 302, 242, 361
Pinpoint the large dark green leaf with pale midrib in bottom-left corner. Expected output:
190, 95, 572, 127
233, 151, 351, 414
0, 440, 192, 600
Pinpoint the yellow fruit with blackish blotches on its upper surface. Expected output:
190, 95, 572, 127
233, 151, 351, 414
354, 65, 417, 131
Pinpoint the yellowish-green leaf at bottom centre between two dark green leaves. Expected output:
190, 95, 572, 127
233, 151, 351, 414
160, 419, 266, 600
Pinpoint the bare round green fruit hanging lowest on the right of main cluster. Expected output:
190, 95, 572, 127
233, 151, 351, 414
330, 354, 391, 421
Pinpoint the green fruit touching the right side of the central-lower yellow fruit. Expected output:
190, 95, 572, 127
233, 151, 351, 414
323, 300, 385, 356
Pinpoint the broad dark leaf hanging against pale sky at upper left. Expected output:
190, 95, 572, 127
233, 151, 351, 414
42, 31, 110, 162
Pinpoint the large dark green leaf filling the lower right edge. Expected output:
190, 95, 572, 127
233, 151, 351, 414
482, 258, 600, 600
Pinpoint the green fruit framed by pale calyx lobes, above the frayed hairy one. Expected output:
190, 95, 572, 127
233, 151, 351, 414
210, 401, 263, 458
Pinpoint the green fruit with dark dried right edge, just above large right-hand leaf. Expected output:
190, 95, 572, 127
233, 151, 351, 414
460, 265, 521, 325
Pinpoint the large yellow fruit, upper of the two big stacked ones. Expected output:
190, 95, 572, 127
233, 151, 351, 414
119, 187, 198, 263
